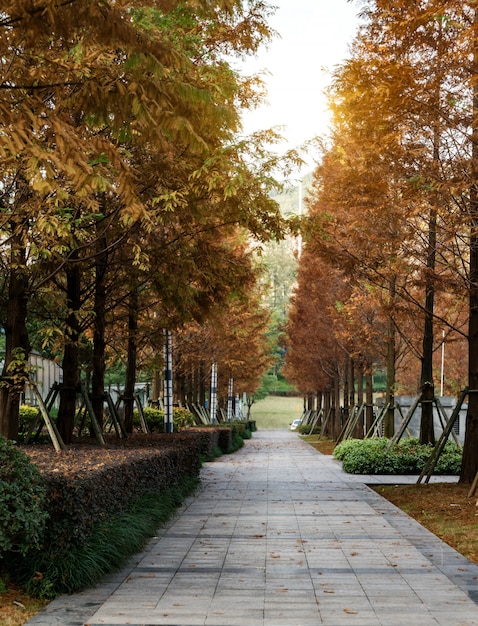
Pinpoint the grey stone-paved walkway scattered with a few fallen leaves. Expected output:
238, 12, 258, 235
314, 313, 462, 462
28, 430, 478, 626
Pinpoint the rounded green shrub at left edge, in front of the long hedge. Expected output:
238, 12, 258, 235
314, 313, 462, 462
0, 436, 48, 558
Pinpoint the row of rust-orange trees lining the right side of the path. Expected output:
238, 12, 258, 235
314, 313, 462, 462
286, 0, 478, 482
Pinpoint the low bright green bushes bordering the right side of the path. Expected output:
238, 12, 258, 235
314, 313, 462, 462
334, 437, 462, 475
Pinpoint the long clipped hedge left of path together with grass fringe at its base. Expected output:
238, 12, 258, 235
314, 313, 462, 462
6, 427, 242, 598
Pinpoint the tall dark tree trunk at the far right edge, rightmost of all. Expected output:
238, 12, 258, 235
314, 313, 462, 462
460, 8, 478, 483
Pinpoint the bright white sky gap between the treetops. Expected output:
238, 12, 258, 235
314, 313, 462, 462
243, 0, 358, 169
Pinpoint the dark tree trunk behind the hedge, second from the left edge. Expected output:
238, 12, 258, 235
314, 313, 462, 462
57, 264, 81, 445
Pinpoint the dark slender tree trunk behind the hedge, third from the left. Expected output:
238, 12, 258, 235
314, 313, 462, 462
91, 237, 108, 428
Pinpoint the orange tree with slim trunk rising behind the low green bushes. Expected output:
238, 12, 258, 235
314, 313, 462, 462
306, 112, 410, 434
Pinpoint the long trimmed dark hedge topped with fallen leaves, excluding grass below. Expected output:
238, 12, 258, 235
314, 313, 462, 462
0, 426, 254, 597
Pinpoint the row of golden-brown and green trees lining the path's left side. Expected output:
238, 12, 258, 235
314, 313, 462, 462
0, 0, 299, 443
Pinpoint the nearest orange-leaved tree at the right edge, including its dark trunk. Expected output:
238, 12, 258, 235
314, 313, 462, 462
344, 0, 478, 482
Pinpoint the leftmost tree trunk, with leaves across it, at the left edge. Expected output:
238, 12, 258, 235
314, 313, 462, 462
0, 235, 30, 439
